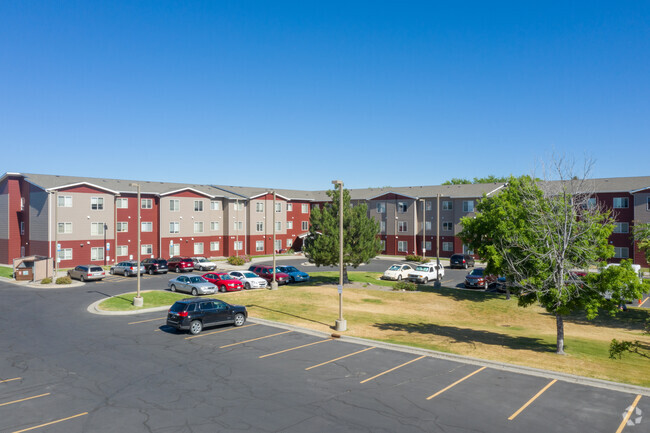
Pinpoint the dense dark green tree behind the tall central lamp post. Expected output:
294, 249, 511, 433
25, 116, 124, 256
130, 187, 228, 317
303, 189, 382, 284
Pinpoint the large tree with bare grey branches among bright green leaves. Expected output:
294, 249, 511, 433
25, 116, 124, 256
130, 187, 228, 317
459, 160, 642, 354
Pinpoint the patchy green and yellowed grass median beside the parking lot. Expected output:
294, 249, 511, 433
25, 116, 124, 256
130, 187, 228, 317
101, 272, 650, 386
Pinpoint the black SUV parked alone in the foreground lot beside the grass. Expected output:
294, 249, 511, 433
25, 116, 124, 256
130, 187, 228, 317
167, 296, 248, 335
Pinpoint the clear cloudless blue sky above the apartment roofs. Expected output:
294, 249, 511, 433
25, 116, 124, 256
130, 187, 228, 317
0, 0, 650, 189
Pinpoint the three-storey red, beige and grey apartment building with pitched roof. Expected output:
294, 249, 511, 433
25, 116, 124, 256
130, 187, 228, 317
0, 173, 650, 267
